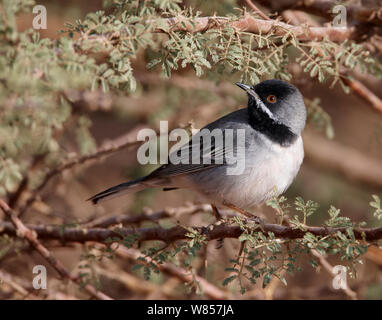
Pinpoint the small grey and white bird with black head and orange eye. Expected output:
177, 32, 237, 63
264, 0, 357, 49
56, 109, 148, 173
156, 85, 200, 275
88, 79, 306, 217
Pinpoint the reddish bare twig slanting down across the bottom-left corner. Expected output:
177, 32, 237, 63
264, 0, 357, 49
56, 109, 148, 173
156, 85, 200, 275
0, 199, 111, 300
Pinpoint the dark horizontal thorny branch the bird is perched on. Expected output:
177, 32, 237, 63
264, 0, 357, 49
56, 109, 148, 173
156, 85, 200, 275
0, 222, 382, 243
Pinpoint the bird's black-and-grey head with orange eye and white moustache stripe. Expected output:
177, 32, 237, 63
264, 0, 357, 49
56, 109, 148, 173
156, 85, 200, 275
237, 79, 306, 145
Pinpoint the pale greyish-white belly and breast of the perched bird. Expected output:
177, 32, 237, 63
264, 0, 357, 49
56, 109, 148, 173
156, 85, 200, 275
179, 137, 304, 208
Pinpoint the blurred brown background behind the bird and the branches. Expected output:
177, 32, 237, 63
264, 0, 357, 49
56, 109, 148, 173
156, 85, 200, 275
0, 0, 382, 299
